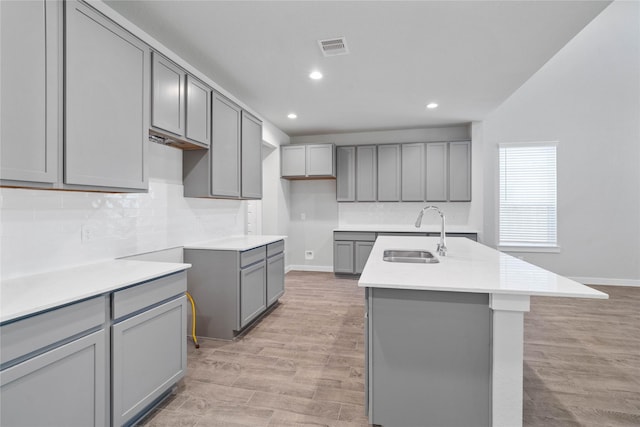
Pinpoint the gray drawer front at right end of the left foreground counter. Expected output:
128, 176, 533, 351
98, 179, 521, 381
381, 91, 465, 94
113, 271, 187, 320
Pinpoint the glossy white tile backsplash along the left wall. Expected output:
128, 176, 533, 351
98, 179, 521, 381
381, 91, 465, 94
0, 180, 246, 279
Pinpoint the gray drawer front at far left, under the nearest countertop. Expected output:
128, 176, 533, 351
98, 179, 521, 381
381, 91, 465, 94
0, 296, 106, 365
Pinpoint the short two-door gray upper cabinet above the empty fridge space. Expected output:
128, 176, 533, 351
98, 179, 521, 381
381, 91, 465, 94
280, 144, 336, 179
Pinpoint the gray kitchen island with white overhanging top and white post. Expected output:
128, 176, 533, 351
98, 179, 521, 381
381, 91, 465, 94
358, 236, 607, 427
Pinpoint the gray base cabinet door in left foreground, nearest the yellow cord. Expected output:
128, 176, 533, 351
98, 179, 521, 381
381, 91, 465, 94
111, 296, 187, 425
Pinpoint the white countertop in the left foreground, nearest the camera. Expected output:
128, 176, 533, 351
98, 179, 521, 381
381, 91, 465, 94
0, 260, 191, 322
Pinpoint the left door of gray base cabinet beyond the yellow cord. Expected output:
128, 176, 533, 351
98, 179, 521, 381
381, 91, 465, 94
240, 261, 267, 328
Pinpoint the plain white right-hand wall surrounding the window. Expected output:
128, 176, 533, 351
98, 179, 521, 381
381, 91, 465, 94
484, 1, 640, 285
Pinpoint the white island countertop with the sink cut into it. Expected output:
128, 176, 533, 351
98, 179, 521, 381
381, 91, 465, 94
358, 236, 608, 299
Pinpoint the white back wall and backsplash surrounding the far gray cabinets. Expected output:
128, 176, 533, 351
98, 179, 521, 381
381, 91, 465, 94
288, 123, 483, 271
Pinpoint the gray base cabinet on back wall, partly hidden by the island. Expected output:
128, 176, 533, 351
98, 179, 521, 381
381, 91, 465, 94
333, 231, 376, 274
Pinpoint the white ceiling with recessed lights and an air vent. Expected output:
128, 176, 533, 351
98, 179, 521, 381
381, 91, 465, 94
106, 0, 610, 136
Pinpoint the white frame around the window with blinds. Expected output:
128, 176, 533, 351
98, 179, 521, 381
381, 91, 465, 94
495, 141, 560, 253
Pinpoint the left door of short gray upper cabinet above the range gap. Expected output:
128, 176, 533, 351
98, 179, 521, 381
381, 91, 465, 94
151, 52, 186, 135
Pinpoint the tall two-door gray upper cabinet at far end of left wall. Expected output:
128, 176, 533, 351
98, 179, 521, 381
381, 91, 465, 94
182, 91, 262, 199
